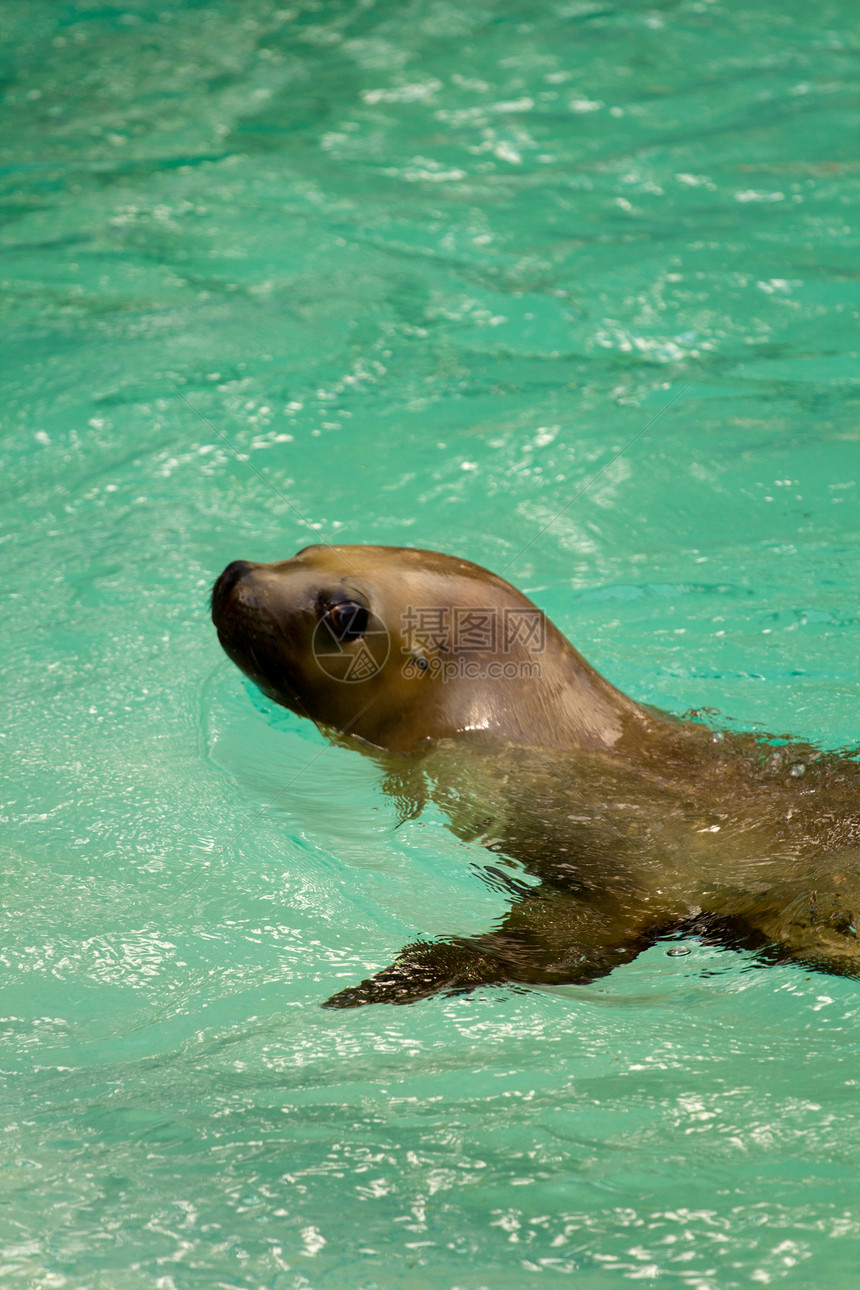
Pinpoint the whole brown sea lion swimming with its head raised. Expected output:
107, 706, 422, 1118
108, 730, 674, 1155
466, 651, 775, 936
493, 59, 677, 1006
211, 546, 860, 1007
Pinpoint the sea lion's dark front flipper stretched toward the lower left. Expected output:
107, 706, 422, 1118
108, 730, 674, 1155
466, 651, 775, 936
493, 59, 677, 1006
322, 882, 658, 1007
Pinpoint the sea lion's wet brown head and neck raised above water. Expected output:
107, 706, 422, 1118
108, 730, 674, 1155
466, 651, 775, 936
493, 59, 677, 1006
211, 544, 629, 751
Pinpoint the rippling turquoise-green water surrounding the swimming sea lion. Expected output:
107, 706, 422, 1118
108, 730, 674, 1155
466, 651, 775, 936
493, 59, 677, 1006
0, 0, 860, 1290
